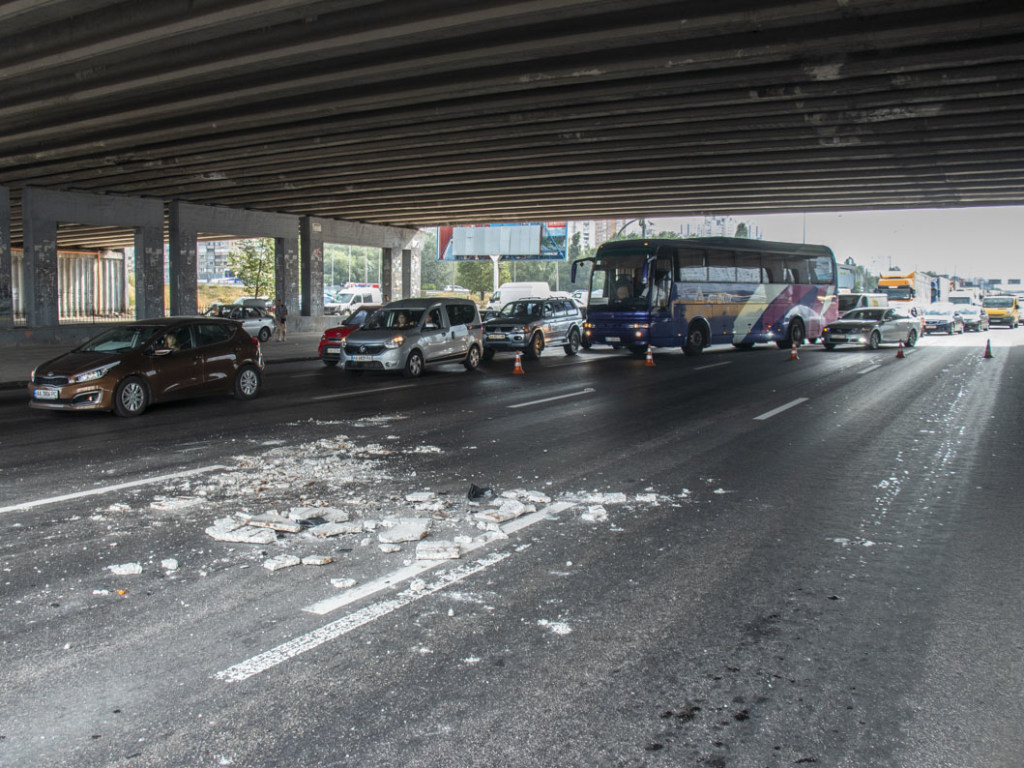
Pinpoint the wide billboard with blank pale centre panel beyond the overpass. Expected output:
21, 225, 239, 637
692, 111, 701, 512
437, 221, 567, 261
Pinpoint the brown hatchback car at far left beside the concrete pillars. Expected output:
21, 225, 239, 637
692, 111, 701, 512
29, 317, 263, 416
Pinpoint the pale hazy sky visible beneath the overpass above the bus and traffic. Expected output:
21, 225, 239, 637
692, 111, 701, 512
650, 207, 1024, 280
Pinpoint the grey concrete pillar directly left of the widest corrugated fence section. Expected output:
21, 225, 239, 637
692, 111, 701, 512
22, 187, 60, 328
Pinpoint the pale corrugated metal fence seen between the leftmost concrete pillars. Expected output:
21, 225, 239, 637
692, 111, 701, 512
10, 249, 135, 325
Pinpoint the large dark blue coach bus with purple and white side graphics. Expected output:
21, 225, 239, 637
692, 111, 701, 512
572, 238, 838, 356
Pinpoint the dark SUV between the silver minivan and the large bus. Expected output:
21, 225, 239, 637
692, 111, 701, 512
483, 298, 583, 359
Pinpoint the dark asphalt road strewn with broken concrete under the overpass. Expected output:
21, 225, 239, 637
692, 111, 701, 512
0, 330, 1024, 768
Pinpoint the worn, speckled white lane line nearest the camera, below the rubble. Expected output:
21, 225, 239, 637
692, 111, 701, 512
214, 552, 512, 683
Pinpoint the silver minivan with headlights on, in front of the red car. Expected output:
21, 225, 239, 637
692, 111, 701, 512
342, 298, 483, 377
